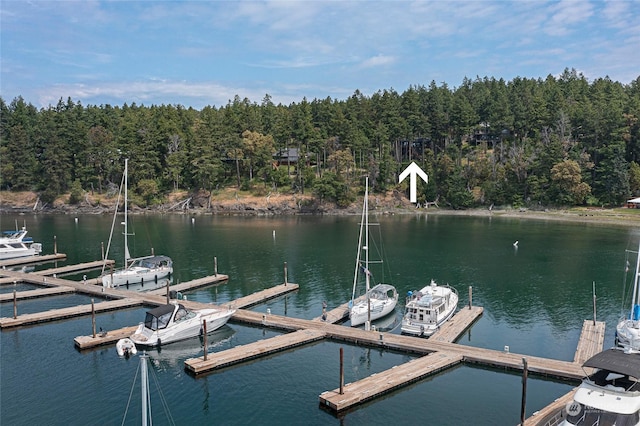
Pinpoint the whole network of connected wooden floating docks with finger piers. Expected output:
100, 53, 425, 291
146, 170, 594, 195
0, 257, 604, 419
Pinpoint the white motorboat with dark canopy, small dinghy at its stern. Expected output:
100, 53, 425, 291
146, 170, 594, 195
130, 303, 236, 347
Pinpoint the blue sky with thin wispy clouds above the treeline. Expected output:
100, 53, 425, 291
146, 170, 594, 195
0, 0, 640, 110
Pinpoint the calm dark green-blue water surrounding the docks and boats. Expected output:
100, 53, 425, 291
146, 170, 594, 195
0, 214, 640, 425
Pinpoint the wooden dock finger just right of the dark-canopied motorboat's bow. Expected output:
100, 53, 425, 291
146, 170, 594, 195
184, 330, 325, 375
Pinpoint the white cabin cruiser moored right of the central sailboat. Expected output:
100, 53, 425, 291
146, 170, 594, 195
401, 280, 458, 337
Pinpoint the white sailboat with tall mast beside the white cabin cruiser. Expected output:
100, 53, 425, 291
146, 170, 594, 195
349, 177, 398, 330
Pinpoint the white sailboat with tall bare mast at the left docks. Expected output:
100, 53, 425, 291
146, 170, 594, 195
102, 159, 173, 290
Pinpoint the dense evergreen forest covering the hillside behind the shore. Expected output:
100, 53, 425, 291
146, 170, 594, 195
0, 69, 640, 209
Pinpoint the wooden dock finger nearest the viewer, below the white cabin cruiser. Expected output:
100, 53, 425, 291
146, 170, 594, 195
319, 352, 462, 412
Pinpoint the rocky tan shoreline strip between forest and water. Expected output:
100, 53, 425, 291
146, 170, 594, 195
0, 190, 640, 226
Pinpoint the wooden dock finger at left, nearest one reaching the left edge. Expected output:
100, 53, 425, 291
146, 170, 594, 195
0, 299, 142, 328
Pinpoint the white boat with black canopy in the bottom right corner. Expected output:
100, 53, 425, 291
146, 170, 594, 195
561, 348, 640, 426
